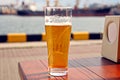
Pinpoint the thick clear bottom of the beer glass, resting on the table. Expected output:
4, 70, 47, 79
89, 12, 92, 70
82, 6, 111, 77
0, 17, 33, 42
49, 68, 68, 76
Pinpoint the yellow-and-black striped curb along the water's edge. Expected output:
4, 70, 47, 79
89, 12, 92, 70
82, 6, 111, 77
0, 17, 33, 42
0, 32, 103, 42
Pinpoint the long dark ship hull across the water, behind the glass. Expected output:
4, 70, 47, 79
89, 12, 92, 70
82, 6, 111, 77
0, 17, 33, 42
17, 7, 111, 17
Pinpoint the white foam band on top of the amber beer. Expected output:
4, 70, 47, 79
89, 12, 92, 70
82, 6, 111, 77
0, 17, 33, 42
45, 16, 72, 26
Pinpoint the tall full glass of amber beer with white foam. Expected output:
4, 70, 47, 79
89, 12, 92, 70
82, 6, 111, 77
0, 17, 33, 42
45, 7, 72, 76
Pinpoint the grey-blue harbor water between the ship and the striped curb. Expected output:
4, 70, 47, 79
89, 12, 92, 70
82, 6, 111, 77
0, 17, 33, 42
0, 15, 105, 35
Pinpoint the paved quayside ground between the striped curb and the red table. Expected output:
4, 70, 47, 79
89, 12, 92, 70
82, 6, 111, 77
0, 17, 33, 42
0, 40, 102, 80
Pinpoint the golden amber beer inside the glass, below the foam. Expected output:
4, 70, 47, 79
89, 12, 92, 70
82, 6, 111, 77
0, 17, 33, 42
45, 25, 71, 68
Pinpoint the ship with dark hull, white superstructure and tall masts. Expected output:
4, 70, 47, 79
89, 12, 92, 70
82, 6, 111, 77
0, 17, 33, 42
17, 0, 118, 17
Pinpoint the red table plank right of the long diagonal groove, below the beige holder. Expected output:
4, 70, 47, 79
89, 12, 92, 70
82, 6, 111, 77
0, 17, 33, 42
74, 57, 120, 80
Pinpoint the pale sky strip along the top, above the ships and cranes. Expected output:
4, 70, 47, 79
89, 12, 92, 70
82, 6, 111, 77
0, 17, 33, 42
0, 0, 120, 10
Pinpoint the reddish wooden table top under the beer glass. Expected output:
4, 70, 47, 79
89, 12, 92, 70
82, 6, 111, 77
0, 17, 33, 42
18, 57, 120, 80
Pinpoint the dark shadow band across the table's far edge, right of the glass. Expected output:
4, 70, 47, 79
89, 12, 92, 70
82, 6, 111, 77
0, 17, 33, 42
69, 57, 119, 68
